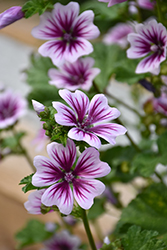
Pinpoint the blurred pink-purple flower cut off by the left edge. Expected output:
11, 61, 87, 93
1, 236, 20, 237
0, 89, 27, 129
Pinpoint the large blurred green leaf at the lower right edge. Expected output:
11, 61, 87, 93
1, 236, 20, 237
115, 183, 167, 238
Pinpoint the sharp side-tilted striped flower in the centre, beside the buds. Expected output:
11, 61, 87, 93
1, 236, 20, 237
53, 89, 126, 148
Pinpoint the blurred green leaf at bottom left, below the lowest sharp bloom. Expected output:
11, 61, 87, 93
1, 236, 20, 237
15, 220, 53, 249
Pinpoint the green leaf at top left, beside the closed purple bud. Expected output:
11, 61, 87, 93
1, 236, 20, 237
22, 0, 53, 18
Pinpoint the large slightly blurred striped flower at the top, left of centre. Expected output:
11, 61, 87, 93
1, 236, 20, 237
32, 2, 100, 66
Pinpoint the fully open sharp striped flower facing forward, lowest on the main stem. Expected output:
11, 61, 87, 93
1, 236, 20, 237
32, 139, 110, 215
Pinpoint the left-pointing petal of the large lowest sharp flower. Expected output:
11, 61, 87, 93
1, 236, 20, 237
32, 155, 64, 187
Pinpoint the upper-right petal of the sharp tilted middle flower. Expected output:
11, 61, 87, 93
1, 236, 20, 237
87, 94, 120, 124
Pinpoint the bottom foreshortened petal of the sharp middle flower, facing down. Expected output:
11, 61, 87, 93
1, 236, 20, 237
68, 128, 101, 149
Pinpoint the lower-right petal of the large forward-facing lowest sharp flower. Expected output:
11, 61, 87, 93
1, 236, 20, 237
73, 179, 105, 209
